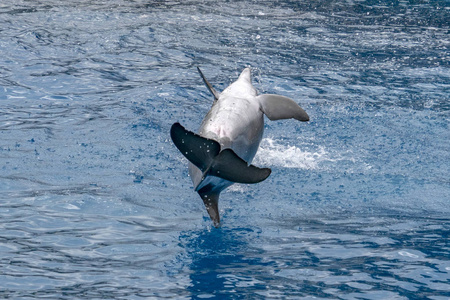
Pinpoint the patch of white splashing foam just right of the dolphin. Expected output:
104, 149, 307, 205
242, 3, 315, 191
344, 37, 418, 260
254, 138, 336, 169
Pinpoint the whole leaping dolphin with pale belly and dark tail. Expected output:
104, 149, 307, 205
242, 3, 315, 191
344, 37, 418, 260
170, 67, 309, 227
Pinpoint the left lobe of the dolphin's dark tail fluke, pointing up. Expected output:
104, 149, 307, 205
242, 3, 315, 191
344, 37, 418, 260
170, 123, 220, 171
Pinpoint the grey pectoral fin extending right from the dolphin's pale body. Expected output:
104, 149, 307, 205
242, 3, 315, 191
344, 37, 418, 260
257, 94, 309, 122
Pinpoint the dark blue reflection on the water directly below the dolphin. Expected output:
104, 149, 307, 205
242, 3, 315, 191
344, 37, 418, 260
180, 227, 264, 299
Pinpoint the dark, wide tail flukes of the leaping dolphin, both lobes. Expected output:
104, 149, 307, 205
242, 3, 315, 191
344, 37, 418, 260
170, 123, 271, 183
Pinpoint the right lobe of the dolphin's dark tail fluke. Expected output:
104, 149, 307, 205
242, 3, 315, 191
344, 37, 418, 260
207, 149, 271, 183
